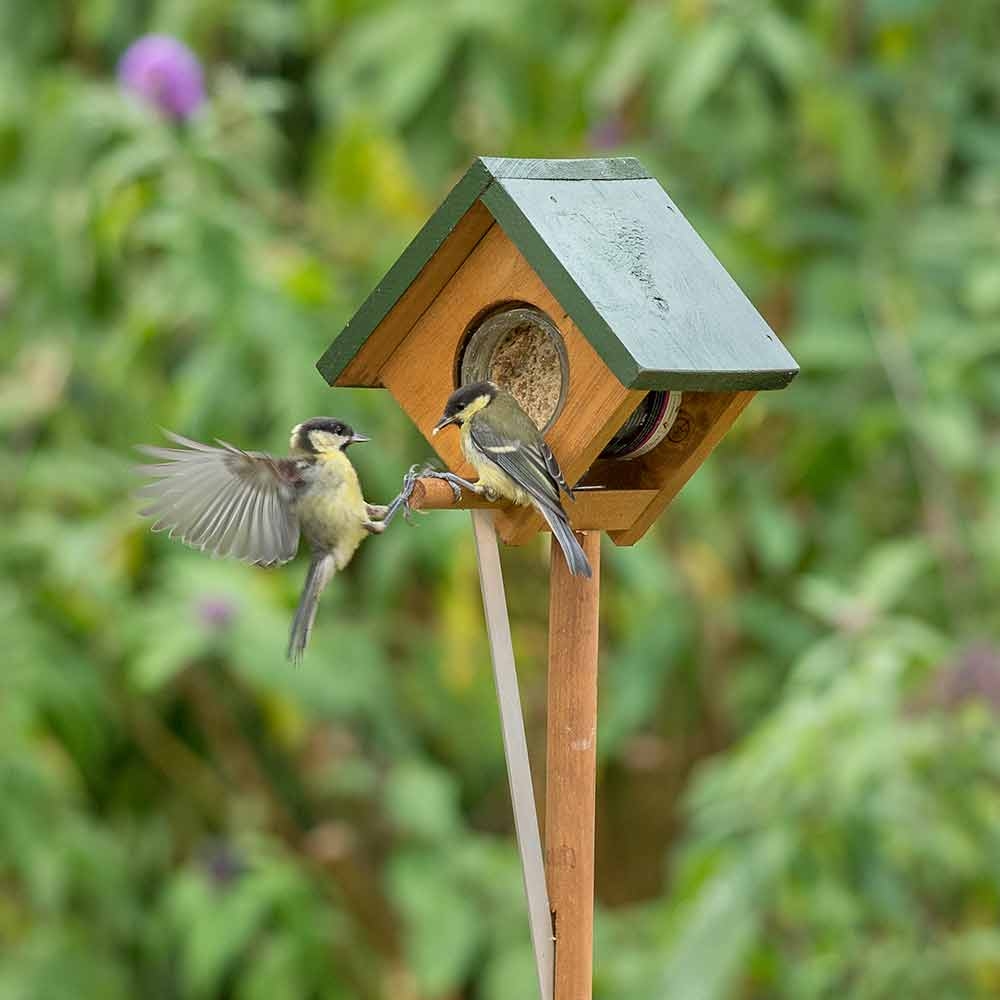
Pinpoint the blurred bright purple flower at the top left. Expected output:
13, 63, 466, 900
118, 35, 205, 121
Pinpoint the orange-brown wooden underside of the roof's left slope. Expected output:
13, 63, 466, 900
336, 201, 493, 386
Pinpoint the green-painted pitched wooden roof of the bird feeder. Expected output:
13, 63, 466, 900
318, 157, 798, 390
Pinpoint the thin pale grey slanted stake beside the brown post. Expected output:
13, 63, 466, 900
472, 510, 554, 1000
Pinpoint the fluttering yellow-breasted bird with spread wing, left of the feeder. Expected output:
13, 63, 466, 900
139, 417, 387, 662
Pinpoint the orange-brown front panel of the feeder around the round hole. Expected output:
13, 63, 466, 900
379, 225, 645, 544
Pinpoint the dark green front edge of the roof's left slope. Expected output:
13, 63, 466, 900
316, 160, 493, 385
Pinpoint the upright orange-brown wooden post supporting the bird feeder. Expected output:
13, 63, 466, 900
545, 531, 601, 1000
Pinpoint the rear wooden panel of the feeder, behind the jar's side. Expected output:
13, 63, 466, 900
584, 392, 755, 545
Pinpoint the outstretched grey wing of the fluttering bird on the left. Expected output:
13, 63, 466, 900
138, 431, 299, 566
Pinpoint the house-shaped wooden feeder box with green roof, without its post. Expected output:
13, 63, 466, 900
318, 158, 798, 545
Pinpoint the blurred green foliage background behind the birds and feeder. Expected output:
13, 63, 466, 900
0, 0, 1000, 1000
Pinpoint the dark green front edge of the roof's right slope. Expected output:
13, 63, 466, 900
482, 184, 639, 386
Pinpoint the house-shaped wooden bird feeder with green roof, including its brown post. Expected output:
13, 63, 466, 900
318, 157, 798, 1000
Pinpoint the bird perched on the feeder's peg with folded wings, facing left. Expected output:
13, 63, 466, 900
423, 382, 590, 576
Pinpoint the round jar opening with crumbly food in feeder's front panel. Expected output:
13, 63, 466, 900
459, 306, 569, 431
